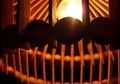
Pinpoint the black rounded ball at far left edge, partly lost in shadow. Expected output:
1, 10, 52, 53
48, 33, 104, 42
2, 24, 18, 49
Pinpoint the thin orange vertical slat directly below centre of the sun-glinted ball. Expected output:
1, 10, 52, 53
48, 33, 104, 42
70, 44, 74, 84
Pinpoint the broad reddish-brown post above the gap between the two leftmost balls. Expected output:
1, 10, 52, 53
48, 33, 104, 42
16, 0, 30, 32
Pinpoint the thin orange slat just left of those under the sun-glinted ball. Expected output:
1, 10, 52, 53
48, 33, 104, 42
52, 48, 56, 84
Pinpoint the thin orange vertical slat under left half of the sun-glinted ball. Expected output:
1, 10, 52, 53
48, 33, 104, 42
61, 44, 65, 84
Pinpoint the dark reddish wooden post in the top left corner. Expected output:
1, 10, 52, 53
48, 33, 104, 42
0, 0, 14, 29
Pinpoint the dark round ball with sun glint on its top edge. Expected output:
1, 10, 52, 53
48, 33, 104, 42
53, 17, 85, 44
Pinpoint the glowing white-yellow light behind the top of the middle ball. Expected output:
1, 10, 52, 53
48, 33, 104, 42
57, 0, 82, 21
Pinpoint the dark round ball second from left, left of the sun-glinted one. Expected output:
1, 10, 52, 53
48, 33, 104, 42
23, 20, 52, 46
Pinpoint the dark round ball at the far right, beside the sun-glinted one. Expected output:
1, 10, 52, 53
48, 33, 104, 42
89, 17, 119, 45
